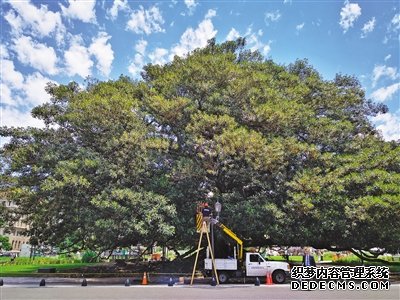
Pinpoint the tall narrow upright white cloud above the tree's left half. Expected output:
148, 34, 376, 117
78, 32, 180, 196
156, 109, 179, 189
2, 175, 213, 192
89, 32, 114, 76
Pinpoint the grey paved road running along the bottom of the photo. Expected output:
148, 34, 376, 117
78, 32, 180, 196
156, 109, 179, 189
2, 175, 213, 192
0, 284, 400, 300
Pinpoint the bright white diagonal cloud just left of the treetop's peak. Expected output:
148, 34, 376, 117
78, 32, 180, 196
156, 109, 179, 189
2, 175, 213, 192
170, 14, 217, 60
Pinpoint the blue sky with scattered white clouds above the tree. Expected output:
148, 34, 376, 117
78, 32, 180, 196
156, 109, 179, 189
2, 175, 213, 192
0, 0, 400, 140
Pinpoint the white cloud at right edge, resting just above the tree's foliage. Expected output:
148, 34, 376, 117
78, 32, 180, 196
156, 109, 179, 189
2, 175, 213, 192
372, 111, 400, 141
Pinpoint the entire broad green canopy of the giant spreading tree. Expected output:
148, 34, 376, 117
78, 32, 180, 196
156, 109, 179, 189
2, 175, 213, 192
0, 39, 400, 251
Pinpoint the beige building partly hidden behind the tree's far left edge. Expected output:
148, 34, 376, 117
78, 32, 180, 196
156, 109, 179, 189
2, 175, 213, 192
0, 200, 29, 253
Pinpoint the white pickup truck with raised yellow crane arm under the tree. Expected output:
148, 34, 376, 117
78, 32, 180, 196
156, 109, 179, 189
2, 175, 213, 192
204, 219, 290, 283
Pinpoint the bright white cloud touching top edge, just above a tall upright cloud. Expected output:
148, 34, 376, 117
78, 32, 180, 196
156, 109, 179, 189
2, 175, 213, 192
60, 0, 96, 23
